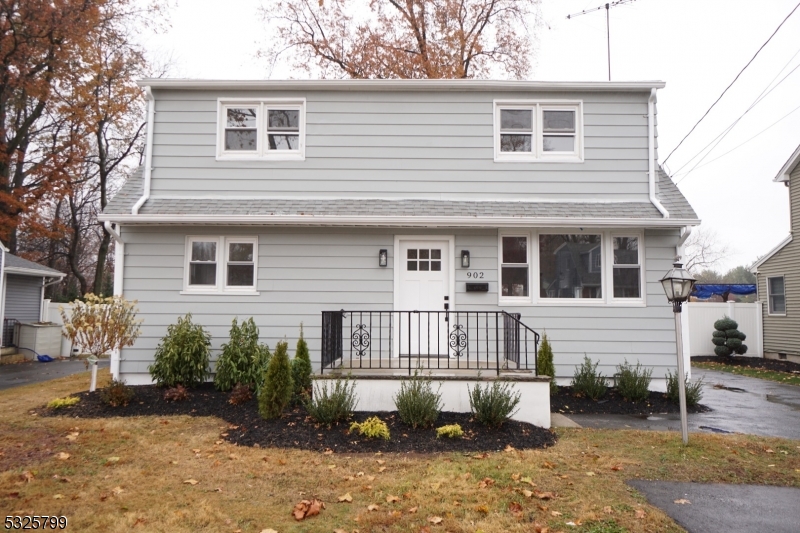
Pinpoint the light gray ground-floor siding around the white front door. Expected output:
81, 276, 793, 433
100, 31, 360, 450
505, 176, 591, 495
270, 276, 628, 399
121, 226, 678, 378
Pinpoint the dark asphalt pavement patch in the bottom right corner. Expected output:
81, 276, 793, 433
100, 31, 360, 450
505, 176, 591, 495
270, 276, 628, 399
628, 479, 800, 533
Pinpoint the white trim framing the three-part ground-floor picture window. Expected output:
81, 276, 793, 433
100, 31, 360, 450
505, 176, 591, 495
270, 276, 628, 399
497, 228, 647, 307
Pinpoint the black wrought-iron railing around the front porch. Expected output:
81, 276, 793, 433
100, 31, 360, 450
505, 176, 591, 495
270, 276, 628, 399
321, 310, 539, 375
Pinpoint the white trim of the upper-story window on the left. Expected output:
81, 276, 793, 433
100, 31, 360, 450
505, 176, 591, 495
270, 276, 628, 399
216, 98, 306, 161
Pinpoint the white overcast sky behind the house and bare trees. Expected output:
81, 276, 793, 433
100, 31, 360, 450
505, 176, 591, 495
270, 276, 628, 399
147, 0, 800, 270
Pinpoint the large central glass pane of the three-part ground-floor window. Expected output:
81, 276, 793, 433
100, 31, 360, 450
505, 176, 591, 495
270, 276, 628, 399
539, 235, 603, 298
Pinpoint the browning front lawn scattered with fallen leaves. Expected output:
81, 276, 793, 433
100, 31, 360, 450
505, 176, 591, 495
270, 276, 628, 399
0, 374, 800, 533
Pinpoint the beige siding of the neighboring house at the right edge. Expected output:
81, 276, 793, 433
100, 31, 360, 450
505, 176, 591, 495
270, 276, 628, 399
758, 166, 800, 355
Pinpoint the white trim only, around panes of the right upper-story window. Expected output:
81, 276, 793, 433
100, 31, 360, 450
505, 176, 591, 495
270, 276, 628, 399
493, 100, 584, 163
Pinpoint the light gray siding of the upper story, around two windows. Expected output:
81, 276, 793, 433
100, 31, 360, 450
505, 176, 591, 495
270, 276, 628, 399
147, 90, 649, 201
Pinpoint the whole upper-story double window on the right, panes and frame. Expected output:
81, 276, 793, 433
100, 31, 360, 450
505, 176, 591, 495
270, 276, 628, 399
494, 101, 583, 162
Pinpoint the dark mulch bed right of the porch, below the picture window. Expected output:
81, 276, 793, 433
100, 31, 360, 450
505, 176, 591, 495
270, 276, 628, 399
550, 387, 711, 415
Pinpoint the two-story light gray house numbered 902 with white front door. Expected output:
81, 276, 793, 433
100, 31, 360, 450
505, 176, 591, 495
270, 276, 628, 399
101, 79, 700, 387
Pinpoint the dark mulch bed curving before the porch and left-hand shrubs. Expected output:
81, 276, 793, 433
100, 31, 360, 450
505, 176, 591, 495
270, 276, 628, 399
39, 383, 556, 453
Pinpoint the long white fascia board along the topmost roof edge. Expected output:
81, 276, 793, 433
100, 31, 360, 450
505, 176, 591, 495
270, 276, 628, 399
136, 78, 666, 92
